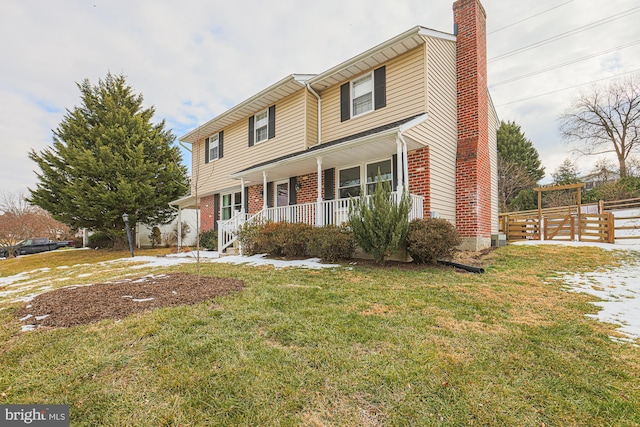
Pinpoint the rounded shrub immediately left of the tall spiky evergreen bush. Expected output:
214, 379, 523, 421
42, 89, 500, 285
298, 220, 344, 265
309, 225, 357, 262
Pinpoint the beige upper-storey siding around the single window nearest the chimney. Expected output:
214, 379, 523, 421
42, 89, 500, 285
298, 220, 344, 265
320, 47, 424, 142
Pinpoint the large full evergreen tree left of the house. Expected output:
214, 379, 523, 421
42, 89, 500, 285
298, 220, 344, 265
29, 73, 188, 244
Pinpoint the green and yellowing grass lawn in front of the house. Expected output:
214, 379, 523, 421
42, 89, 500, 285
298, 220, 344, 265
0, 246, 640, 426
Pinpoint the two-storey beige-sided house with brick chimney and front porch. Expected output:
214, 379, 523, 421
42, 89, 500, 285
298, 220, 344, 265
172, 0, 498, 254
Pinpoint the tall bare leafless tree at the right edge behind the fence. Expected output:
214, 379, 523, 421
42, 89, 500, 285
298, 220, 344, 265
560, 75, 640, 178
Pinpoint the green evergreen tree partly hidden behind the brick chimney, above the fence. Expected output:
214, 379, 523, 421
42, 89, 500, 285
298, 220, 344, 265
497, 121, 544, 212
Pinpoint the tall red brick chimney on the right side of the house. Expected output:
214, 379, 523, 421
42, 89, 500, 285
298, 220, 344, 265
453, 0, 491, 251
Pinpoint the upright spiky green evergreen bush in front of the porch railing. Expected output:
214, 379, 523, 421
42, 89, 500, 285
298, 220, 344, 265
349, 176, 411, 264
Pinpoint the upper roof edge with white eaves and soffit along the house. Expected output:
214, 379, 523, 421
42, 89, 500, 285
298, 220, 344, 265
179, 26, 456, 144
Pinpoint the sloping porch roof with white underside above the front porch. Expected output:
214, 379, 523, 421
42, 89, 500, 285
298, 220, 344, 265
229, 113, 428, 183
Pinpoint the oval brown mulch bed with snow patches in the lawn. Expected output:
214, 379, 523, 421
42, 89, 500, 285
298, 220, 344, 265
16, 273, 244, 327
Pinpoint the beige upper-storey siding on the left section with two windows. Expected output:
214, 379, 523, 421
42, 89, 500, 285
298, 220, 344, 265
192, 89, 308, 196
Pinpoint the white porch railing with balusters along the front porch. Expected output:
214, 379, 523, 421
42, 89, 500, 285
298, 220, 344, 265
218, 192, 424, 252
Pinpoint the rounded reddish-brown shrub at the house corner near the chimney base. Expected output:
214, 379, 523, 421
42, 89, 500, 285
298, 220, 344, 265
407, 218, 462, 264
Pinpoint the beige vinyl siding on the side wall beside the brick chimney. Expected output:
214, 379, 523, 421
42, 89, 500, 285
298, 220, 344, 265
408, 38, 458, 224
